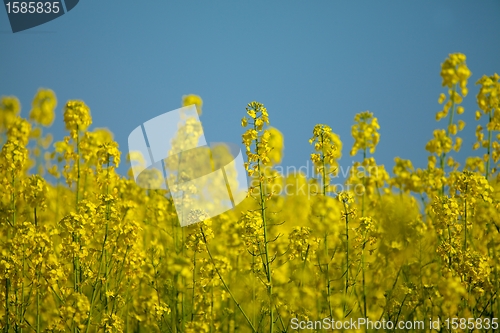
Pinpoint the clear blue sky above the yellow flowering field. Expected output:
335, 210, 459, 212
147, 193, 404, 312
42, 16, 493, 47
0, 0, 500, 180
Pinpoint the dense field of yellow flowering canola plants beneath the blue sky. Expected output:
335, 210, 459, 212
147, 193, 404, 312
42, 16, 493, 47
0, 53, 500, 333
